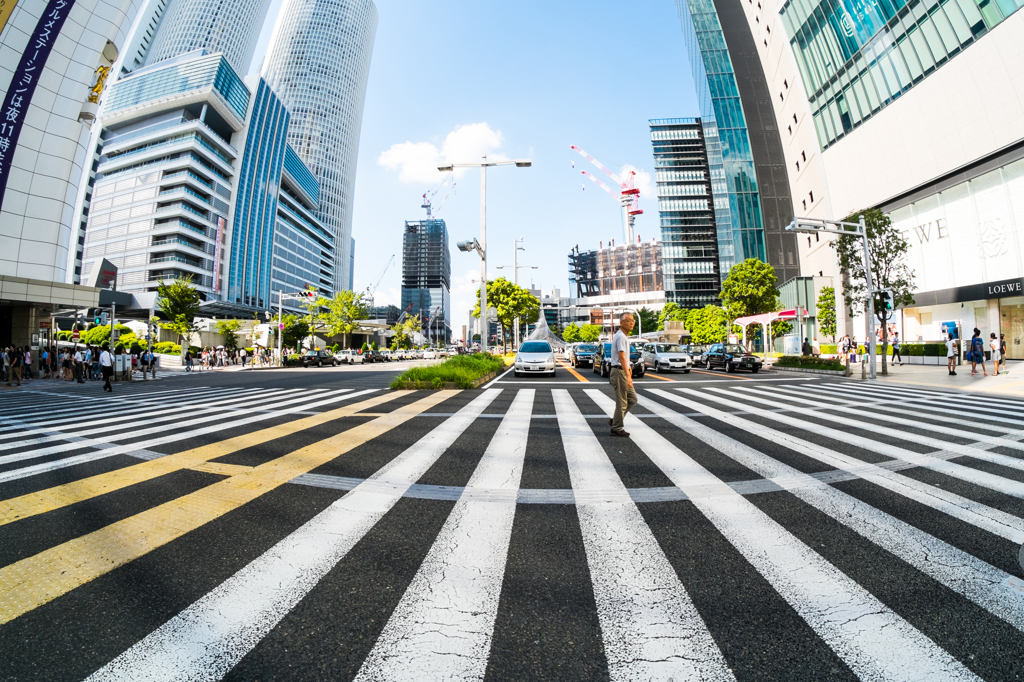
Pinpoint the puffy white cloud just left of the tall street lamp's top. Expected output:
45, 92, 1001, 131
377, 123, 508, 185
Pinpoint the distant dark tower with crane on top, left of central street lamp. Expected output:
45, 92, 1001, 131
401, 218, 452, 341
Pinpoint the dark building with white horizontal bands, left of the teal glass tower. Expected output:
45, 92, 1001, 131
650, 119, 722, 308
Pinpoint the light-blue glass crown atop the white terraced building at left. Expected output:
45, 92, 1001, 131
103, 54, 250, 121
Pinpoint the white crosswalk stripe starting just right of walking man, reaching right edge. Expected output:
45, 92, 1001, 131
640, 391, 1024, 631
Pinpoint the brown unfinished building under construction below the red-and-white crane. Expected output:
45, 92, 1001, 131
569, 240, 664, 298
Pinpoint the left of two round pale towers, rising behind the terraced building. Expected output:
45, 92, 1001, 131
143, 0, 270, 76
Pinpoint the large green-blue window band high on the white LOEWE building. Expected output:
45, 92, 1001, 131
780, 0, 1024, 150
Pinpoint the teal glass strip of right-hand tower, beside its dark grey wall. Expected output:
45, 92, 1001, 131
676, 0, 768, 272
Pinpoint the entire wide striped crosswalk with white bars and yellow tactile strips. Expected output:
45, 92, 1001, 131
0, 381, 1024, 681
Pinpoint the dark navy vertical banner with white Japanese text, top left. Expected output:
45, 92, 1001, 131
0, 0, 75, 209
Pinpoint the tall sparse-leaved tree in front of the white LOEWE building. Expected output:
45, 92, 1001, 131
831, 209, 914, 374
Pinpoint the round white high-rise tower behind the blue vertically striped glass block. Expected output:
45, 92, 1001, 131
264, 0, 377, 289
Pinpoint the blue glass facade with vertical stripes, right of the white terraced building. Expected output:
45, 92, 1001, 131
227, 79, 289, 308
